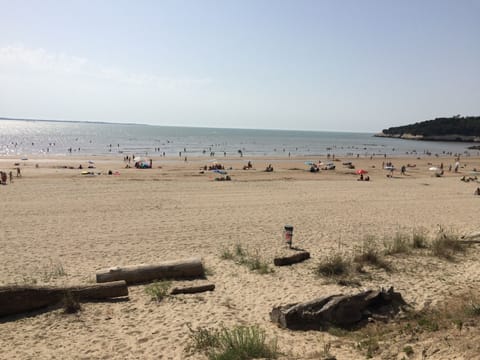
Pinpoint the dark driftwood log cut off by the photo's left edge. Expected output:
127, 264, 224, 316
0, 281, 128, 316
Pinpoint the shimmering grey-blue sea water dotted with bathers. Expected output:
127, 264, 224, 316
0, 120, 478, 156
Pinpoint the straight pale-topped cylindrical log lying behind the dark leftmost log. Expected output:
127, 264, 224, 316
97, 258, 205, 283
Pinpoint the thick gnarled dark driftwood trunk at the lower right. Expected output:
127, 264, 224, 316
270, 287, 406, 330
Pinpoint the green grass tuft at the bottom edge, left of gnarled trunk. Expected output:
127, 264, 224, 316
189, 326, 279, 360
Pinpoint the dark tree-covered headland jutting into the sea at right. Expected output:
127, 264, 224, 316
382, 115, 480, 137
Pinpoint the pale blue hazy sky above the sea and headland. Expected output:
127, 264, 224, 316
0, 0, 480, 132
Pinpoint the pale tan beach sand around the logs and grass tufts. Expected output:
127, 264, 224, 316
0, 157, 480, 359
